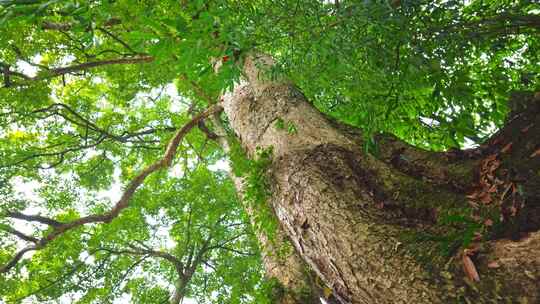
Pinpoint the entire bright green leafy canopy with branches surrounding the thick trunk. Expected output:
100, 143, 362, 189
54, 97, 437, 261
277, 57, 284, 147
0, 0, 540, 303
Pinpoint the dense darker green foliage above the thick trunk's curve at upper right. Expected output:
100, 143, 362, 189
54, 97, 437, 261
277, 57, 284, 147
236, 0, 540, 150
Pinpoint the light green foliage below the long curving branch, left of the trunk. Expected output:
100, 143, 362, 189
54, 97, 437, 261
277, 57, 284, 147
0, 166, 262, 303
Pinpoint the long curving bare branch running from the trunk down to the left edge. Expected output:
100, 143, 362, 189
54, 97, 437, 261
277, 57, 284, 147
0, 105, 222, 273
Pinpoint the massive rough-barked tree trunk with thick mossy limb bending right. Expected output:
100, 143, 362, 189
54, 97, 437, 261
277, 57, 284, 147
223, 56, 540, 303
